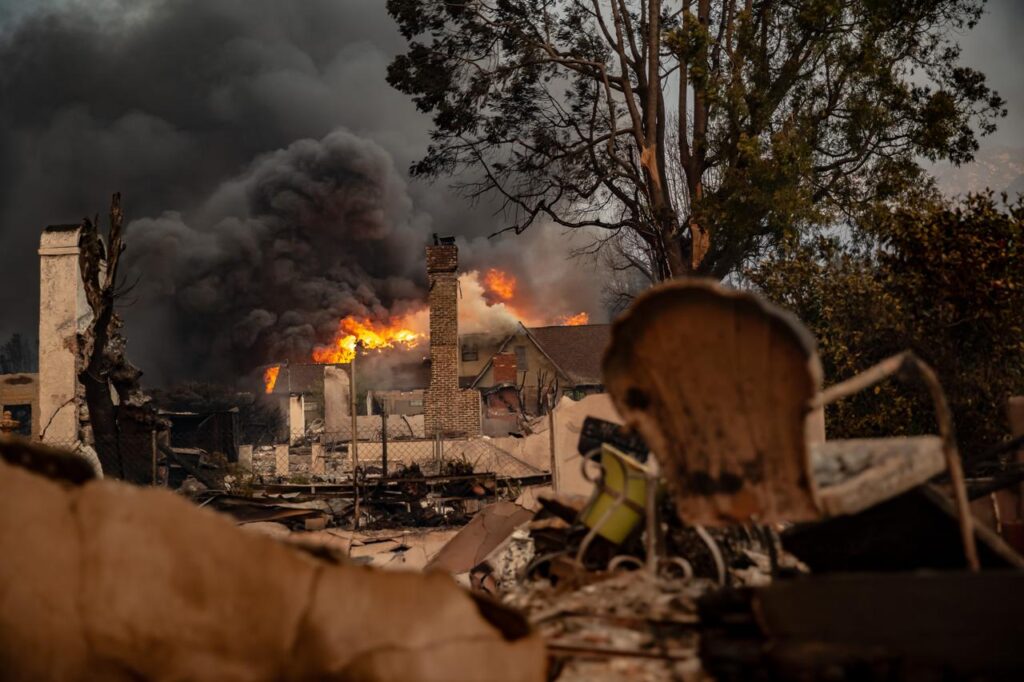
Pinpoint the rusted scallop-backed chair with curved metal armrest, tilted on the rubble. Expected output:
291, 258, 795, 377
604, 281, 978, 569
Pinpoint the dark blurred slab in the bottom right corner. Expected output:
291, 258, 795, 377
699, 571, 1024, 682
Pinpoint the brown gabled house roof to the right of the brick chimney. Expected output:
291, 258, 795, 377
472, 325, 611, 386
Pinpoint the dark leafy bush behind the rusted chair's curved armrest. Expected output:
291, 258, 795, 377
748, 188, 1024, 458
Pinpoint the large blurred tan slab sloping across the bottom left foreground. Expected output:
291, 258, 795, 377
0, 442, 545, 681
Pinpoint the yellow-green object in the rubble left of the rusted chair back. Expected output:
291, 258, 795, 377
582, 443, 647, 545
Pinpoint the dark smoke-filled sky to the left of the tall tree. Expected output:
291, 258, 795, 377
0, 0, 601, 384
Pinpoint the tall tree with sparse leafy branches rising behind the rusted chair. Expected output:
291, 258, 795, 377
387, 0, 1005, 281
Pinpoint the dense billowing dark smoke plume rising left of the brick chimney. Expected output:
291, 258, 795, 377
128, 130, 429, 376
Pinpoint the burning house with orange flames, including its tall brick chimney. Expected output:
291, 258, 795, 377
263, 238, 610, 442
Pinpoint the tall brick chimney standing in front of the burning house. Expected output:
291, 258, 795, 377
424, 237, 480, 436
